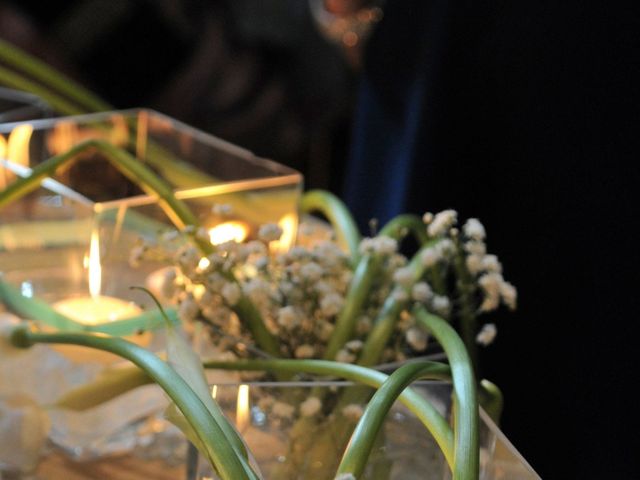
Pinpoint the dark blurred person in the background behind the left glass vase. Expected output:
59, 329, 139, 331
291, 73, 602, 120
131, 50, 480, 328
0, 0, 354, 190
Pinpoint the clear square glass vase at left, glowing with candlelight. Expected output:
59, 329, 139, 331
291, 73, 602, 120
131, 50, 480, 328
0, 110, 302, 331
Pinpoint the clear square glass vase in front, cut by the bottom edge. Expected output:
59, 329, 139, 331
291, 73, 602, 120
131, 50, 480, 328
187, 381, 540, 480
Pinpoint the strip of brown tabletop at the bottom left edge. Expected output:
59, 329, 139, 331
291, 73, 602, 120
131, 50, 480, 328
37, 454, 186, 480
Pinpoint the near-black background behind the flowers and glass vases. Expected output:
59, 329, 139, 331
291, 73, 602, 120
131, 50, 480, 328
0, 0, 640, 478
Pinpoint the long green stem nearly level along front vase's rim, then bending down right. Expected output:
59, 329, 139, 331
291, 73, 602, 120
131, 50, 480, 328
204, 359, 454, 468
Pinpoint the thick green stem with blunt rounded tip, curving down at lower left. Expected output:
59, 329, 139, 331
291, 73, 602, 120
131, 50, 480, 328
10, 327, 258, 480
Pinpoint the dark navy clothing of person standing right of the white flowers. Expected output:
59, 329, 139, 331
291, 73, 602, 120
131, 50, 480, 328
344, 0, 640, 478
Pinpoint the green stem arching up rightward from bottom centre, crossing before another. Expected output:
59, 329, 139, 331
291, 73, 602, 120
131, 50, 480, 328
338, 362, 452, 478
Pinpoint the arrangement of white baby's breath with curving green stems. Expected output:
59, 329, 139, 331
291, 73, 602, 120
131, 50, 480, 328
0, 39, 516, 480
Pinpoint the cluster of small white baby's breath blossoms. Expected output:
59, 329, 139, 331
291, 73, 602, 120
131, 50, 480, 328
132, 212, 517, 366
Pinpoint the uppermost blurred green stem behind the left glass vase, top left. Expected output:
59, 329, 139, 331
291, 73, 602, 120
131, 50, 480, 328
0, 40, 113, 113
